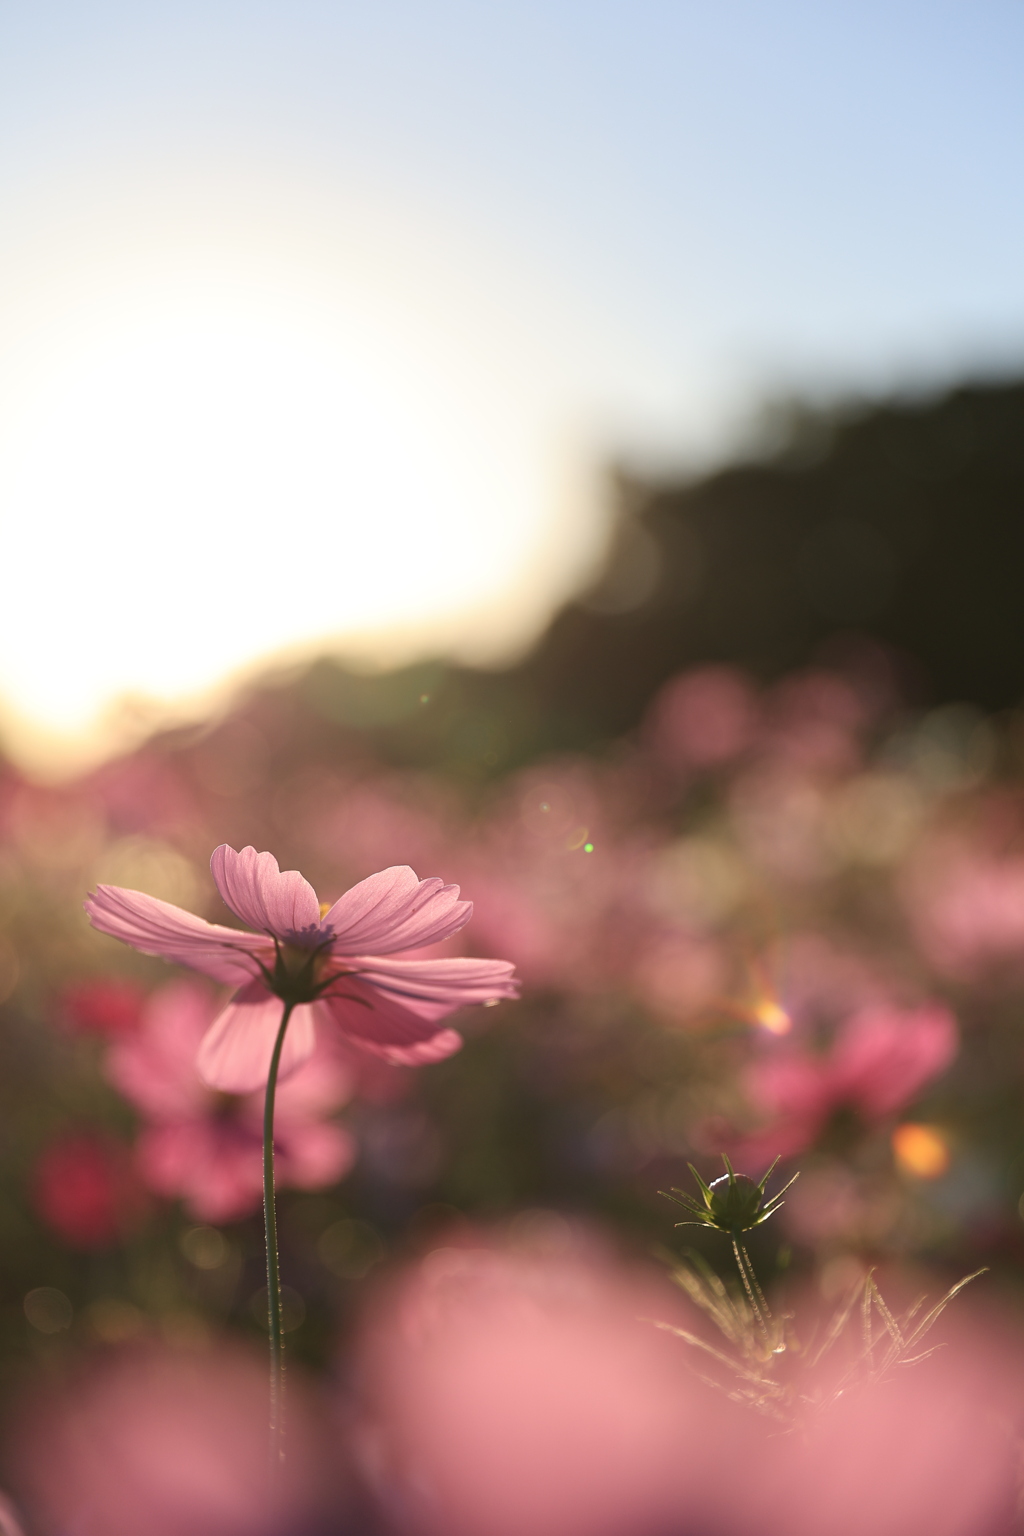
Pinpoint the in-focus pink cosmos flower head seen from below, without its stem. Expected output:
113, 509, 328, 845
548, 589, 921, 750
84, 843, 517, 1094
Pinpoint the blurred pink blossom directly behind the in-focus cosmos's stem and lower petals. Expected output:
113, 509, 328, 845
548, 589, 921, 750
106, 980, 355, 1221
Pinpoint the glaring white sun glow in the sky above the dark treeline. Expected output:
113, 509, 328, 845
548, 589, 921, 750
0, 258, 564, 774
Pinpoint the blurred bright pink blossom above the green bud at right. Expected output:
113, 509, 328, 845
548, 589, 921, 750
745, 1003, 958, 1160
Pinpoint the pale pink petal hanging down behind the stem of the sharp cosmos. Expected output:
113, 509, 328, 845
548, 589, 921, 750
195, 982, 316, 1094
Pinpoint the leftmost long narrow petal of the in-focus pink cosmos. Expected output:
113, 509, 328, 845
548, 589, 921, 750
84, 885, 273, 986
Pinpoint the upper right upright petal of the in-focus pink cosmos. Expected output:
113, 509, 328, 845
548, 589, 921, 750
322, 865, 473, 955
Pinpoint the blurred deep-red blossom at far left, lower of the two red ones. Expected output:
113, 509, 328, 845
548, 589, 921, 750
32, 1130, 146, 1249
